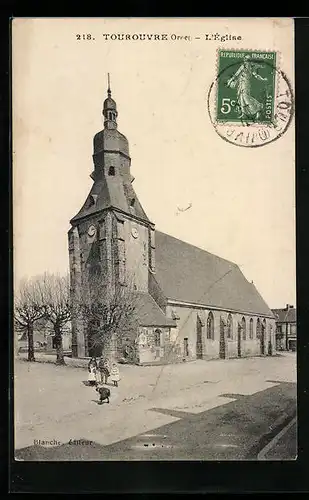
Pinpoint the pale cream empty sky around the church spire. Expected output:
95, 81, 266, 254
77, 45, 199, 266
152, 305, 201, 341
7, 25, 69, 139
12, 18, 296, 308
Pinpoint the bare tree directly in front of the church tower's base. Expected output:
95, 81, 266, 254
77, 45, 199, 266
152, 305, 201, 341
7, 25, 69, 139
80, 272, 139, 362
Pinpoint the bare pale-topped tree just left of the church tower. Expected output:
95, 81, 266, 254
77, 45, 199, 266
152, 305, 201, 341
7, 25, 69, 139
39, 273, 71, 365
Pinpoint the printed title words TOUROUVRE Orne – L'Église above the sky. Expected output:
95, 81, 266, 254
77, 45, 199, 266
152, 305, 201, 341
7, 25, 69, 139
102, 33, 242, 42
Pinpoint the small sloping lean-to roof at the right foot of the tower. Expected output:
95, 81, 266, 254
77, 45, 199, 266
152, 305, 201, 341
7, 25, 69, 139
135, 292, 176, 327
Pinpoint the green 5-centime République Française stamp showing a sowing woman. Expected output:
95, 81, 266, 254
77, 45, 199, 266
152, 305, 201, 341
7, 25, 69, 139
216, 49, 277, 125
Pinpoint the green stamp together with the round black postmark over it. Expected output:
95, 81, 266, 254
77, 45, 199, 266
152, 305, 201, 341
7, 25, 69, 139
208, 49, 293, 147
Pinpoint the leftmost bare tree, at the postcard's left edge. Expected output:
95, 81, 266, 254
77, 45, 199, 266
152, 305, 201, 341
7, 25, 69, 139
14, 277, 46, 361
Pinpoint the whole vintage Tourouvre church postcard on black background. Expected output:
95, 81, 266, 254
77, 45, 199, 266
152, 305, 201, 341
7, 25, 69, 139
12, 18, 297, 462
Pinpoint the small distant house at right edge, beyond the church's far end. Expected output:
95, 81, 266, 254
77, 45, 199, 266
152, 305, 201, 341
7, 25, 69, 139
272, 304, 297, 351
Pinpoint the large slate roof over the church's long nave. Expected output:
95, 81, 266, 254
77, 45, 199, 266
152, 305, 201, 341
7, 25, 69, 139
156, 231, 274, 318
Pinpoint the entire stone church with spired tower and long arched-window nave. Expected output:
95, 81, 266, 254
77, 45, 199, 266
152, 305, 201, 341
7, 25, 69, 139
68, 81, 275, 364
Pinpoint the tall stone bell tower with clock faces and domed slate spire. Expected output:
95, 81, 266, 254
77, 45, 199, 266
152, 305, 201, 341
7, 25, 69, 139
68, 75, 155, 357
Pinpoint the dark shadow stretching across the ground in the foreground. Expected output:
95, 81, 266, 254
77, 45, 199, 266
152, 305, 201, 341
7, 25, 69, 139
15, 381, 296, 461
